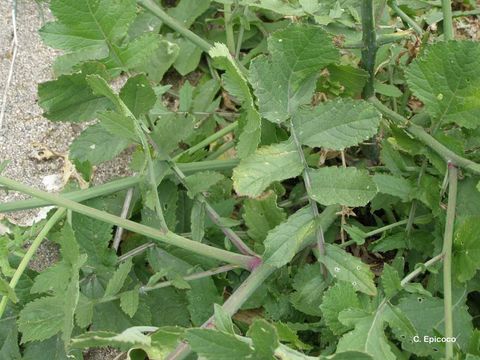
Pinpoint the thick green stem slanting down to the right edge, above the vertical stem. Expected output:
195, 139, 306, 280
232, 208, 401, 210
369, 97, 480, 174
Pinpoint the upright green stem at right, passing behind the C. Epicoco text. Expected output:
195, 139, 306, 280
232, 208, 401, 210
443, 163, 458, 360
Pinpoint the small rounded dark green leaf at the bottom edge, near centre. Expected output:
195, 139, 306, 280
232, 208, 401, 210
247, 319, 280, 360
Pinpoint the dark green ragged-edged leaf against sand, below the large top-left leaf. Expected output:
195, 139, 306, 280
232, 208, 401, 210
38, 63, 112, 122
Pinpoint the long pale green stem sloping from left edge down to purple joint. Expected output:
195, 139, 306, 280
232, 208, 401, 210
0, 176, 257, 269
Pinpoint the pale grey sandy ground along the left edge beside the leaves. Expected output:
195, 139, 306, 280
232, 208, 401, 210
0, 0, 131, 229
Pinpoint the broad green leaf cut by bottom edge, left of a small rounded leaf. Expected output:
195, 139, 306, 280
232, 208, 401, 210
186, 329, 253, 360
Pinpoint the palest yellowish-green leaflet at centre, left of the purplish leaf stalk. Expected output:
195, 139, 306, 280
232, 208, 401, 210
233, 141, 303, 197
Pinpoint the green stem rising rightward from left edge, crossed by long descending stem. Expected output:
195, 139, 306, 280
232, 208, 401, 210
0, 159, 239, 213
